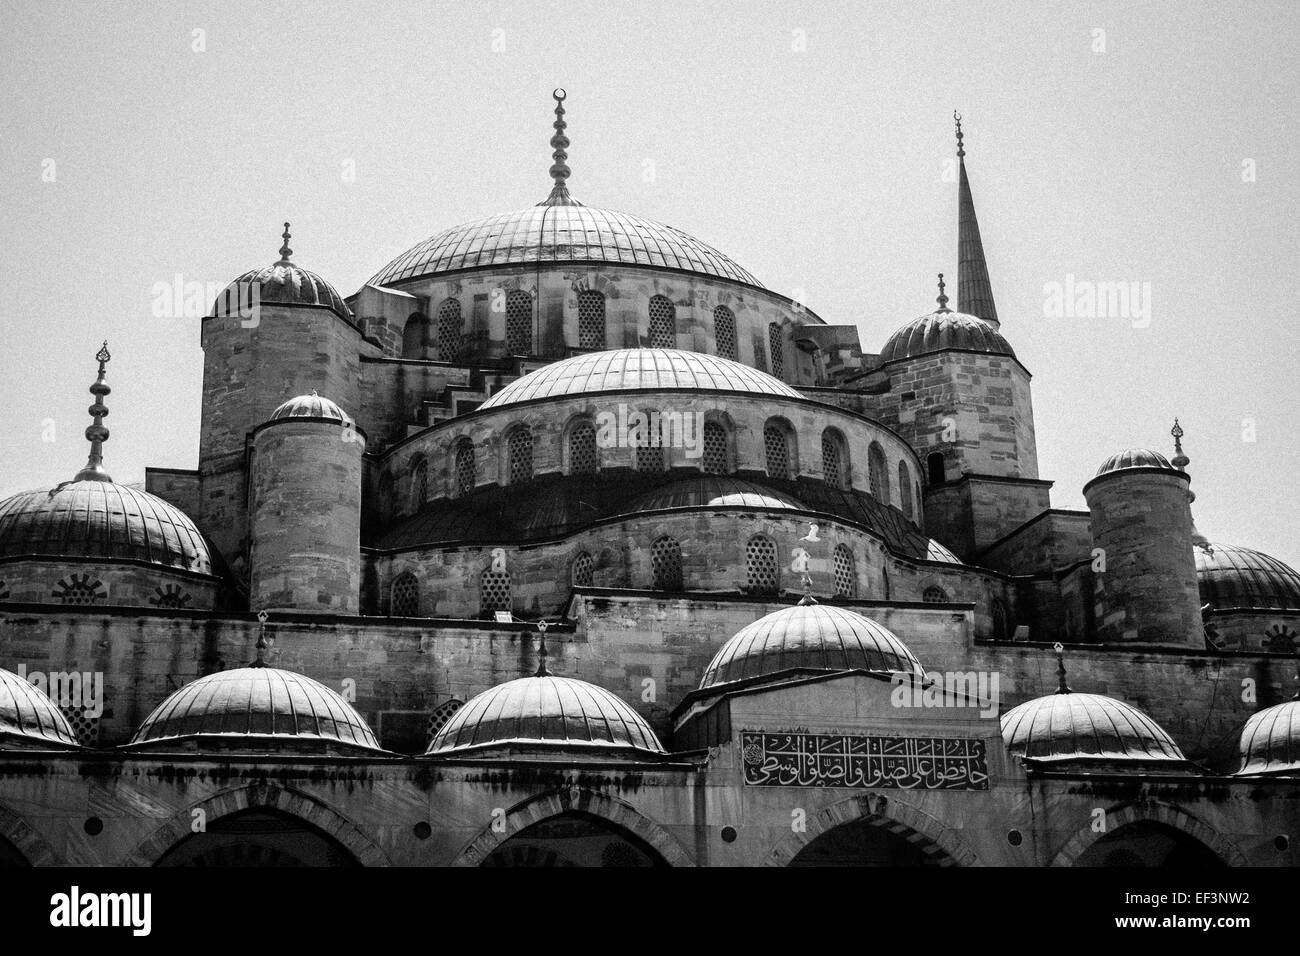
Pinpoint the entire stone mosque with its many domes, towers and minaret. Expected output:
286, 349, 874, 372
0, 90, 1300, 868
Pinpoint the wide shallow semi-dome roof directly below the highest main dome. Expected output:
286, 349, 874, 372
478, 349, 801, 408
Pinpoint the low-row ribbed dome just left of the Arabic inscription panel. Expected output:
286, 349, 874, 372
428, 675, 664, 753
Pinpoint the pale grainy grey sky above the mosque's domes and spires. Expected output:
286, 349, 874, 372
0, 0, 1300, 567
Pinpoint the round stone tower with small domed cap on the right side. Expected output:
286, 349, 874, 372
1083, 449, 1203, 646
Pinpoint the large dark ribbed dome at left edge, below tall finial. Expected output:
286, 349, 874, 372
0, 481, 213, 574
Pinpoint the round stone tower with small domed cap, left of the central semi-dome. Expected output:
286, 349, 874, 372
248, 392, 365, 614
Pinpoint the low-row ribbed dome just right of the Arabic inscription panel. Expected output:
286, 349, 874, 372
1002, 693, 1184, 761
